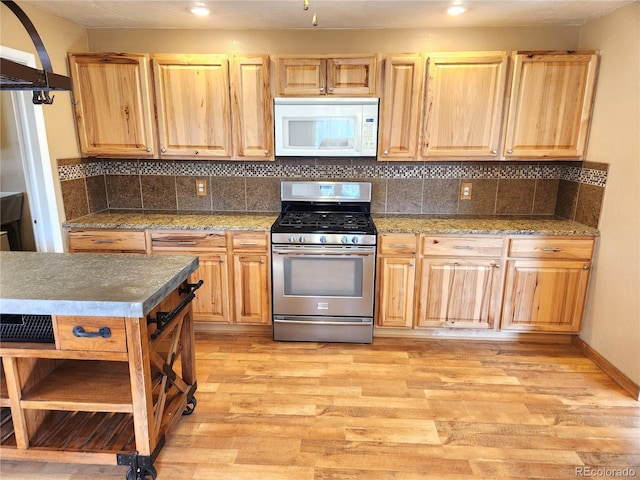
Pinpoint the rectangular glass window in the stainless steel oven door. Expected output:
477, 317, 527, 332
284, 257, 363, 298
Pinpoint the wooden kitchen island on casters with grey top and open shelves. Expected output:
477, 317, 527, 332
0, 252, 199, 480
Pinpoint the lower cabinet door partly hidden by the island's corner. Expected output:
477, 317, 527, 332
189, 253, 231, 323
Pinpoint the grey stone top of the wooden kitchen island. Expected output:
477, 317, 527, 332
0, 252, 199, 317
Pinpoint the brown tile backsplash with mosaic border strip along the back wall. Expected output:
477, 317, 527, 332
58, 158, 608, 227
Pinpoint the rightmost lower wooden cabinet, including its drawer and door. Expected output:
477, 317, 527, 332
501, 237, 594, 333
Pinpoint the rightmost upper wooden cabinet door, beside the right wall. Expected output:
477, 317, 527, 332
504, 52, 598, 160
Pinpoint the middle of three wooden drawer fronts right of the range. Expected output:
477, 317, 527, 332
421, 235, 503, 257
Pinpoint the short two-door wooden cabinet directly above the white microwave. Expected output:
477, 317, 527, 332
274, 55, 377, 97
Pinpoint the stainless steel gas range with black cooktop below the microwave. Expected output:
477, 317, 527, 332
271, 182, 377, 343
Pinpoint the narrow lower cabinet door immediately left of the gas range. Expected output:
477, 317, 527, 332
233, 253, 271, 324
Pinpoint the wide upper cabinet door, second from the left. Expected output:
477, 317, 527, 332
152, 55, 232, 158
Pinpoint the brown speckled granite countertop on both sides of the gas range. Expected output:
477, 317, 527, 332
64, 212, 599, 236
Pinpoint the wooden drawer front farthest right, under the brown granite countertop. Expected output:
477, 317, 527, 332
509, 237, 594, 260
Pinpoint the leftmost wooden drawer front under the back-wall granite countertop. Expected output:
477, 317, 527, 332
69, 230, 147, 253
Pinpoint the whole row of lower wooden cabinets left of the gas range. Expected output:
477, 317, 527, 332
68, 229, 271, 325
